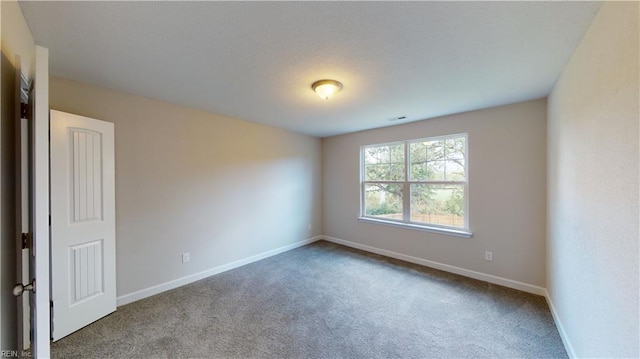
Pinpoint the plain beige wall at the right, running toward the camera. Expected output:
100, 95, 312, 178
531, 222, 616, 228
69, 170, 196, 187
547, 2, 640, 358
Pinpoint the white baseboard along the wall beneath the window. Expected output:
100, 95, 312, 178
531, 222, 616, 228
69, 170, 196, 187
322, 236, 546, 296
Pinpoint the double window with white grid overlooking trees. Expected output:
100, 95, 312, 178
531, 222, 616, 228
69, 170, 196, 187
360, 134, 470, 236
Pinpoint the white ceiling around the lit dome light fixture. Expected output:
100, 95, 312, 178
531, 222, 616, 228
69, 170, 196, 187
20, 2, 601, 137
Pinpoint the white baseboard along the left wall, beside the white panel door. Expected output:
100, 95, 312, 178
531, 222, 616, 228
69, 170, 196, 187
116, 236, 323, 306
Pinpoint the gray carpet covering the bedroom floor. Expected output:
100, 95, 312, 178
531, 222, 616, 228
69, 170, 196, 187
52, 241, 567, 358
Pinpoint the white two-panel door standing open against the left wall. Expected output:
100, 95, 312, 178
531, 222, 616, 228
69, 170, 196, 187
51, 110, 116, 341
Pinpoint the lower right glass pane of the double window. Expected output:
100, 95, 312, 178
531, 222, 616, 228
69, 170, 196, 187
411, 184, 465, 228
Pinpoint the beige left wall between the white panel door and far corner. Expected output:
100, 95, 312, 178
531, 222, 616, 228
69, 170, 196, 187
50, 77, 322, 296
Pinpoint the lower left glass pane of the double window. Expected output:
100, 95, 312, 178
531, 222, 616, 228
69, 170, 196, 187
364, 183, 402, 220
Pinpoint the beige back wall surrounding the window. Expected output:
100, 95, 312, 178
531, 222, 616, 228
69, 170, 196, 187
322, 99, 546, 287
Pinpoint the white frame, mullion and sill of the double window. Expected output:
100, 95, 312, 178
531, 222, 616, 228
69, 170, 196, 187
358, 133, 473, 238
